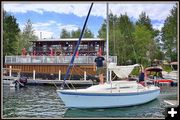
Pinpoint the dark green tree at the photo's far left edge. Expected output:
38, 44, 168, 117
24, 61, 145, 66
3, 11, 20, 56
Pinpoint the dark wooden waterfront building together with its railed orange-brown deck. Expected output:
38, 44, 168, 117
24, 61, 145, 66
5, 38, 117, 79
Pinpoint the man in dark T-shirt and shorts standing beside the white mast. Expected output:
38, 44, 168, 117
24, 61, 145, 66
94, 52, 105, 84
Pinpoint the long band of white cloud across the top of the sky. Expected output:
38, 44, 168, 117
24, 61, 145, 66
4, 2, 175, 21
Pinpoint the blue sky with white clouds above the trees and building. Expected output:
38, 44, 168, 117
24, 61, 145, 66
2, 1, 176, 38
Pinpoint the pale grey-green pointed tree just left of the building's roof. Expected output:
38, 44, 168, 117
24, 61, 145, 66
21, 19, 38, 51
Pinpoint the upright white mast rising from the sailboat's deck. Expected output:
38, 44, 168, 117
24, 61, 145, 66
106, 2, 109, 82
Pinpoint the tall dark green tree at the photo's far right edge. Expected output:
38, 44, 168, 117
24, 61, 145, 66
161, 5, 177, 61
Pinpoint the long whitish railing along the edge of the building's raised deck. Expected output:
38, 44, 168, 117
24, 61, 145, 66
5, 56, 117, 64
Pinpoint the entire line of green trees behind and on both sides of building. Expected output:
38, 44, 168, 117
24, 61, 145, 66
3, 5, 178, 64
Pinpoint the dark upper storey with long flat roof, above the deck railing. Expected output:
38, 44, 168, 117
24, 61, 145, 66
31, 38, 105, 56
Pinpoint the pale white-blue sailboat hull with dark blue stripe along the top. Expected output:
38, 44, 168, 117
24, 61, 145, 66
57, 86, 160, 108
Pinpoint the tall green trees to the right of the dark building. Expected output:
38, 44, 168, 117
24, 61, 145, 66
98, 6, 177, 65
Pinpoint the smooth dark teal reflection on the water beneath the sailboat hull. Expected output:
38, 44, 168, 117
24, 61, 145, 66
64, 99, 164, 118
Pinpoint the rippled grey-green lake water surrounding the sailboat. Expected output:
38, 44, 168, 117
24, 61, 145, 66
2, 85, 177, 118
